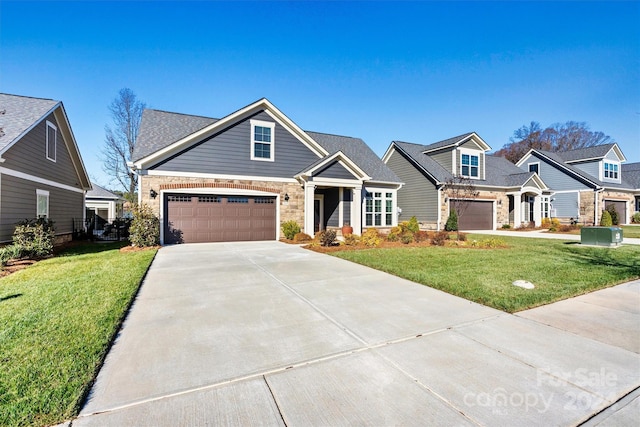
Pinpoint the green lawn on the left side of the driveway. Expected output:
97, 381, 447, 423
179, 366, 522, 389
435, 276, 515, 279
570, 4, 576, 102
0, 244, 156, 426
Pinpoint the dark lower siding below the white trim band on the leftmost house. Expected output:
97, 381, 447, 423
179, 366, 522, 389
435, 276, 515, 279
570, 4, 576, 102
0, 175, 84, 242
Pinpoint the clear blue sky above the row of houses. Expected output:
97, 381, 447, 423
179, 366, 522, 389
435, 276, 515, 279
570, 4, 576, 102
0, 0, 640, 188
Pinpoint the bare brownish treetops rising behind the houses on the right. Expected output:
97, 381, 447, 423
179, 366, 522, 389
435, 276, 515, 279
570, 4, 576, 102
495, 121, 615, 163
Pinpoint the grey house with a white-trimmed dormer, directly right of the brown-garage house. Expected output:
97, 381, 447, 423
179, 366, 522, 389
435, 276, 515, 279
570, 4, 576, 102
382, 132, 549, 230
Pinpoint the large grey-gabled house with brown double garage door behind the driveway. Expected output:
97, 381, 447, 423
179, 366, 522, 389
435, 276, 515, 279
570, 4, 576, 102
131, 98, 401, 244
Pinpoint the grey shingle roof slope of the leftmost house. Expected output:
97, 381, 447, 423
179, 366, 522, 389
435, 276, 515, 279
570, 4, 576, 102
0, 93, 60, 151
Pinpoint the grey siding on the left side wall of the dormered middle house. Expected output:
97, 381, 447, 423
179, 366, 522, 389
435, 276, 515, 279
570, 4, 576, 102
387, 150, 439, 223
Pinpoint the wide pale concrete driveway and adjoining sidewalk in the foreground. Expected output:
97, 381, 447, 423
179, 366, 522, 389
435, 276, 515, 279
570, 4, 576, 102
72, 242, 640, 426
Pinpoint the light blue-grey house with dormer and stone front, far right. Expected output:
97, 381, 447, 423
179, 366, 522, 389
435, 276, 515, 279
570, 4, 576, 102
516, 144, 640, 225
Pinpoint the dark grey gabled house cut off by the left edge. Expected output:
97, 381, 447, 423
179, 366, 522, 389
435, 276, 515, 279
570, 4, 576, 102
0, 94, 91, 243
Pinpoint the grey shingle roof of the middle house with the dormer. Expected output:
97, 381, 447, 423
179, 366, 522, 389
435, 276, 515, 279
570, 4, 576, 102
393, 140, 533, 187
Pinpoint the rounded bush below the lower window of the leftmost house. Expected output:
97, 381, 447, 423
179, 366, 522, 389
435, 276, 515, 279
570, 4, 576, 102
13, 218, 54, 258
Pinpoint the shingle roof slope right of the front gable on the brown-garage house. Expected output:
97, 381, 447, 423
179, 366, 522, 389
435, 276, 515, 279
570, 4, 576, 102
305, 131, 402, 182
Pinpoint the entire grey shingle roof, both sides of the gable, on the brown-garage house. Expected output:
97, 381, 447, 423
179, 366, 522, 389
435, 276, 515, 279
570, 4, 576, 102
131, 109, 402, 183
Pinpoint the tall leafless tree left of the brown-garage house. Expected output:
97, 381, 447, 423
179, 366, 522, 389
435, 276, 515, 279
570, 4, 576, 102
102, 88, 145, 200
